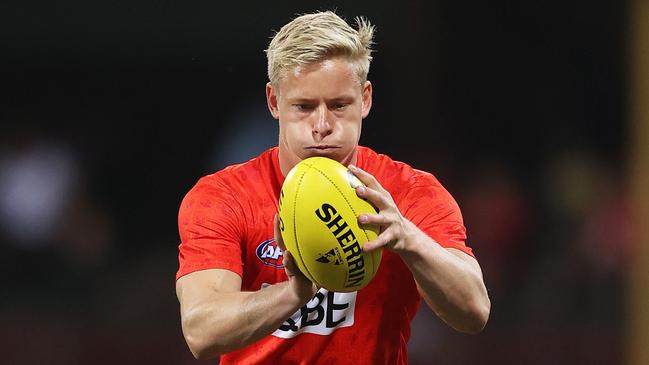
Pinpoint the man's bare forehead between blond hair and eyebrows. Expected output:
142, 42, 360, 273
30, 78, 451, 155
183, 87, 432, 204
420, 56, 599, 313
279, 58, 361, 98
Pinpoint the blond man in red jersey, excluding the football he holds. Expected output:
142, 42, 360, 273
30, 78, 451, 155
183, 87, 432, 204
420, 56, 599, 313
176, 12, 490, 364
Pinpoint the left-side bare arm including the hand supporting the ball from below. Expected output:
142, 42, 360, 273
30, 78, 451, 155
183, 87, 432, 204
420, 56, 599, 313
176, 216, 315, 359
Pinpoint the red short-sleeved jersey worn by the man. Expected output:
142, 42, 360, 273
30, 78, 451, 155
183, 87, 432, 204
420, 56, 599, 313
176, 146, 472, 365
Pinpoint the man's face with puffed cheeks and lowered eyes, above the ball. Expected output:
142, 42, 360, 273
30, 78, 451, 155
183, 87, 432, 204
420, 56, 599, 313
266, 58, 372, 175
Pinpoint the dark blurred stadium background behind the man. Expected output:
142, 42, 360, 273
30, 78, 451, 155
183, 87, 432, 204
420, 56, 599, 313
0, 0, 649, 364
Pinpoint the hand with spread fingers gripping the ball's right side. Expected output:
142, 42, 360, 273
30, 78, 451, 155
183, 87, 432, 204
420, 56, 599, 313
349, 165, 412, 253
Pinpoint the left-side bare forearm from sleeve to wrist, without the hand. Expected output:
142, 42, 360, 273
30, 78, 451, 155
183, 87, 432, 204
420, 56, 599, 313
181, 281, 308, 359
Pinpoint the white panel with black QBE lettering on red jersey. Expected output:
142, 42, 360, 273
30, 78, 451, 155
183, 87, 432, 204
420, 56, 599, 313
264, 285, 357, 338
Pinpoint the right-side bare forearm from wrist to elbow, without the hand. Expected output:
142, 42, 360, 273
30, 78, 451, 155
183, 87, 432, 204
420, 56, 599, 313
400, 222, 491, 333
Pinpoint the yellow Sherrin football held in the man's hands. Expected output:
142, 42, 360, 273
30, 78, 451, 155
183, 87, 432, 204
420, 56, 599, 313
279, 157, 382, 292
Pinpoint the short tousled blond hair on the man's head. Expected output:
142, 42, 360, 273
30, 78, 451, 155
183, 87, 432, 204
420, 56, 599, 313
266, 11, 374, 86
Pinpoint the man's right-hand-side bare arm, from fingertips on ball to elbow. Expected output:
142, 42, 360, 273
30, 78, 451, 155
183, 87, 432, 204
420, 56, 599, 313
350, 166, 491, 333
